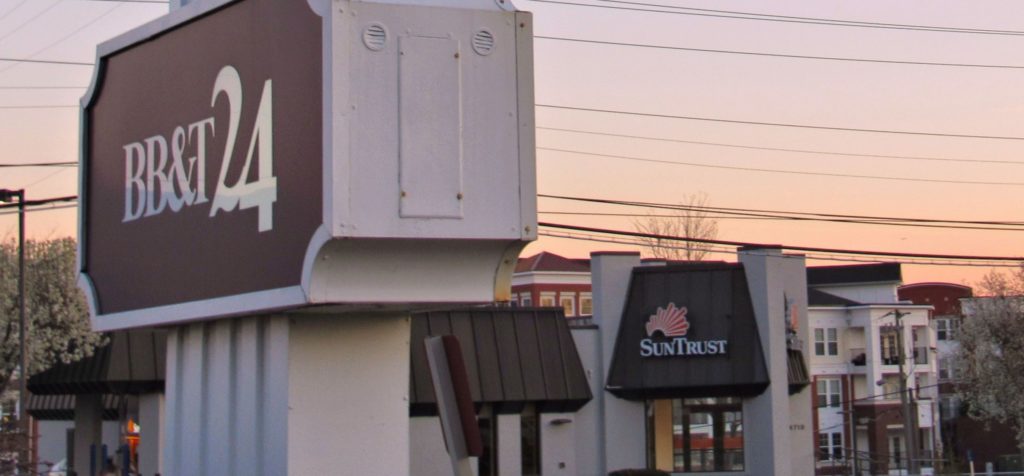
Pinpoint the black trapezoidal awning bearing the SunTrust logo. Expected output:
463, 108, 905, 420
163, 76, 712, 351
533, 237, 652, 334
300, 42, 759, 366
606, 263, 769, 399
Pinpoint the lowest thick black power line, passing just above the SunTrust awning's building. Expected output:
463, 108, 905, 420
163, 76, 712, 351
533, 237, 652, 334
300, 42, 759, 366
538, 222, 1024, 262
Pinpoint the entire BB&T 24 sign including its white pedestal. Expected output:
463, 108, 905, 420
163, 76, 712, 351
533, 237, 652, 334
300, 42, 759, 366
79, 0, 537, 468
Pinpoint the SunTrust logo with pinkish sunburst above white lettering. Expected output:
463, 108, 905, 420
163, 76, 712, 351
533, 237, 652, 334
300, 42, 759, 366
640, 302, 727, 357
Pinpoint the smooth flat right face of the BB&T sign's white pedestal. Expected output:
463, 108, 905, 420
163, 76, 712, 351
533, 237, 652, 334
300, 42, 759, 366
288, 314, 411, 475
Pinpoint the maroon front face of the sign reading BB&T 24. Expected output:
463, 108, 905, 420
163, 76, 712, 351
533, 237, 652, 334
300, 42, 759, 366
81, 0, 323, 315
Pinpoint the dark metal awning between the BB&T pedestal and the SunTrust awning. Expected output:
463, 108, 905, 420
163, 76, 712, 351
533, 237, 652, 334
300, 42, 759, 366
409, 307, 592, 416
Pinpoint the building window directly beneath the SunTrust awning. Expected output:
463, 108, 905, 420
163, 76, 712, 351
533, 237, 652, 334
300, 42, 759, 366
647, 397, 743, 473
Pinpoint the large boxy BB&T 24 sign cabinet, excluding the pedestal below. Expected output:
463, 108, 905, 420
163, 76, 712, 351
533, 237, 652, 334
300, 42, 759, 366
80, 0, 537, 330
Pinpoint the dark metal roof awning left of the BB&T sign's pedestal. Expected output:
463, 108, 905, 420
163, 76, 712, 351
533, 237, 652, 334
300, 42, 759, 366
29, 330, 167, 395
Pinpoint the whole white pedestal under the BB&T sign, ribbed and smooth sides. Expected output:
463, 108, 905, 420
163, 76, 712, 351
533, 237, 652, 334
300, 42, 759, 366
164, 314, 410, 476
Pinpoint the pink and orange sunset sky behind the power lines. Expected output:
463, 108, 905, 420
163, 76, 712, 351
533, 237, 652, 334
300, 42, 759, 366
0, 0, 1024, 285
